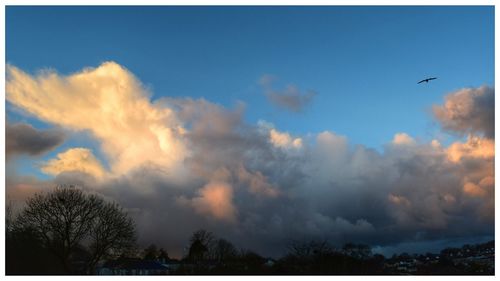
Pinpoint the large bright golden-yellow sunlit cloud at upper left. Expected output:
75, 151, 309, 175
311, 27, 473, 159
6, 62, 186, 178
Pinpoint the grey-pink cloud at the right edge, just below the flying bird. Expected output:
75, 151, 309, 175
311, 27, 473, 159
433, 86, 495, 138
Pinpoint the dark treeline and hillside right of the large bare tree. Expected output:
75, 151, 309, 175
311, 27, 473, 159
136, 230, 494, 275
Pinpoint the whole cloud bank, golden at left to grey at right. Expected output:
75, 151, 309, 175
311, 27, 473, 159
7, 63, 494, 256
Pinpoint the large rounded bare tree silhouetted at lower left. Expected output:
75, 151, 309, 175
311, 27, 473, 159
14, 186, 135, 273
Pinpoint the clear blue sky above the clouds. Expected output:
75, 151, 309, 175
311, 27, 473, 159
6, 7, 494, 149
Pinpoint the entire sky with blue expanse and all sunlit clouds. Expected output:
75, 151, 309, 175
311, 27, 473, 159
6, 6, 494, 255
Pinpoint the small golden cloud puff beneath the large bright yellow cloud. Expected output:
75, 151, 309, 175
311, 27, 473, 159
41, 147, 106, 179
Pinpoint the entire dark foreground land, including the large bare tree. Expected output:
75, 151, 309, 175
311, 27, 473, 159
6, 186, 495, 275
